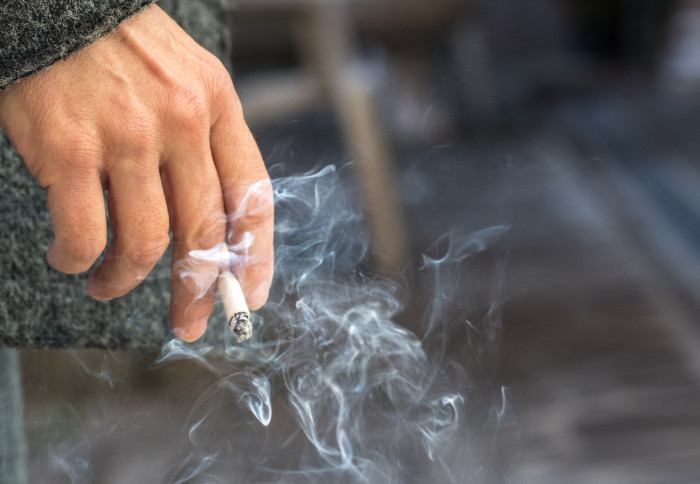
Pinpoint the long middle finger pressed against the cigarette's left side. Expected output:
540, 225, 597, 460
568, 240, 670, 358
163, 139, 226, 341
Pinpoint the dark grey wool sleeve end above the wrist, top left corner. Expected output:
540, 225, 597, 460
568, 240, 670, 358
0, 0, 154, 90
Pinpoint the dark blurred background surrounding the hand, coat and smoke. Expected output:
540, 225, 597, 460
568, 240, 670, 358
23, 0, 700, 483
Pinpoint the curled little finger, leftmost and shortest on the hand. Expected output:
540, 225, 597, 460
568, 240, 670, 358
46, 169, 107, 274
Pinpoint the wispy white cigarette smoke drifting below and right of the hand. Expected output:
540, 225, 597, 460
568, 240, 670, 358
30, 167, 509, 484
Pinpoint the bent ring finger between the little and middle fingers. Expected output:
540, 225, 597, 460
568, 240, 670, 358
87, 160, 170, 300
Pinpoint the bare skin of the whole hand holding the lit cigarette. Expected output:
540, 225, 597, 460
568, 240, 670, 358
0, 6, 273, 341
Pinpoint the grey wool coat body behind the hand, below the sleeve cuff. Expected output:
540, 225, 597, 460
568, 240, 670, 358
0, 0, 231, 350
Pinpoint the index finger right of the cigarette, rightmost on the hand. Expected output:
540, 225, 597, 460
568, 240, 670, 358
211, 93, 274, 309
